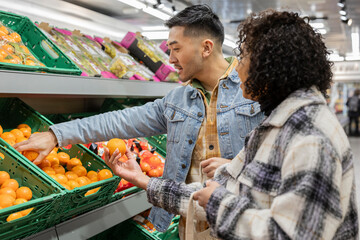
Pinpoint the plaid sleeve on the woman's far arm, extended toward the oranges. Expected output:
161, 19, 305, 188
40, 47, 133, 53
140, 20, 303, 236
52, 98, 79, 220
147, 178, 206, 221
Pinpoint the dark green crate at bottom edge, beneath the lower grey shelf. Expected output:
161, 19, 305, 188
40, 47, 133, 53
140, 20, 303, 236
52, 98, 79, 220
89, 216, 180, 240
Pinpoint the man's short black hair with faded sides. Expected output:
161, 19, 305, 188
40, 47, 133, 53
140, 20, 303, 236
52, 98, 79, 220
165, 4, 224, 46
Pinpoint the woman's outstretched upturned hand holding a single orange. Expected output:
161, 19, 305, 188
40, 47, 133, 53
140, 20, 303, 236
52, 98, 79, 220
105, 148, 150, 190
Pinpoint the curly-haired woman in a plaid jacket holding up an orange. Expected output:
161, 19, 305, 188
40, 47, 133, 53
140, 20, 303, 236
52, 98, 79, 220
107, 10, 358, 239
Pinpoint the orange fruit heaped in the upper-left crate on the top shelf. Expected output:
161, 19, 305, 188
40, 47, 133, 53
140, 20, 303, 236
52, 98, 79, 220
0, 22, 45, 66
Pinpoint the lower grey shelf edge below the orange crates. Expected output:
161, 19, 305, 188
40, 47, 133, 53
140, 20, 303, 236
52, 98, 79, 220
56, 191, 152, 240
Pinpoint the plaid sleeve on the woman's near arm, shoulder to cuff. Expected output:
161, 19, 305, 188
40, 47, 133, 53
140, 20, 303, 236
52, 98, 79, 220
206, 137, 357, 239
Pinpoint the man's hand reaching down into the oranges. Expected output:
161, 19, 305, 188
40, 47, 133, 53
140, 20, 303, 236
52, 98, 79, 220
14, 131, 57, 165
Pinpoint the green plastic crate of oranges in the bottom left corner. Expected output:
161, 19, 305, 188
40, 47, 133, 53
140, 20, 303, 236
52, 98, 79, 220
0, 145, 65, 240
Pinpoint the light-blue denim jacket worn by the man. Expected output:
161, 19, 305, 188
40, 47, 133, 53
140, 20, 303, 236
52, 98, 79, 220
50, 69, 263, 231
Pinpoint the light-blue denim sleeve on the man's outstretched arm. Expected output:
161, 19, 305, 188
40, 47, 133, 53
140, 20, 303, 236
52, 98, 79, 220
50, 98, 167, 147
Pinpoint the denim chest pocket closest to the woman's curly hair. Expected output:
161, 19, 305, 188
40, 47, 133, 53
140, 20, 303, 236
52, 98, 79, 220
235, 103, 263, 138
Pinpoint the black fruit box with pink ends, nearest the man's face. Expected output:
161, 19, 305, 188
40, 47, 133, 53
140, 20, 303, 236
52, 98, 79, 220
121, 32, 172, 81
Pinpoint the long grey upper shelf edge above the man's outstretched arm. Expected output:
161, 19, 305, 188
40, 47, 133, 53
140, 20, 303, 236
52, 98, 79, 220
0, 70, 180, 98
